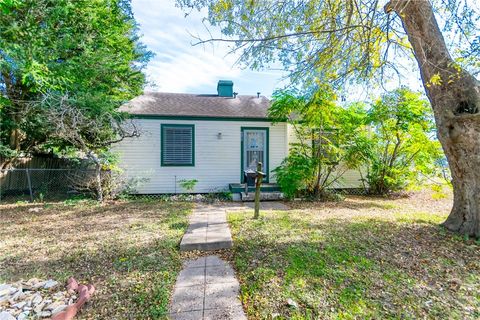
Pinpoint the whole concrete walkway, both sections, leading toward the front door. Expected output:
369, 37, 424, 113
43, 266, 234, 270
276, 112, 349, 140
170, 204, 247, 320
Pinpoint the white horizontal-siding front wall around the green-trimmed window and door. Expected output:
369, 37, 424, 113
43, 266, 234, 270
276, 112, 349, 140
113, 119, 288, 194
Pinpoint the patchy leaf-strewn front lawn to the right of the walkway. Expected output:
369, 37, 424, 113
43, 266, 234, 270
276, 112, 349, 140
229, 194, 480, 319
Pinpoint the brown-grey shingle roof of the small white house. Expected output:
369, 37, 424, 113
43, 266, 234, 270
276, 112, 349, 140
120, 92, 270, 119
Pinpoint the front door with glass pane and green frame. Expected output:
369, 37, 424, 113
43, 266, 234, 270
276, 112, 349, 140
242, 128, 268, 182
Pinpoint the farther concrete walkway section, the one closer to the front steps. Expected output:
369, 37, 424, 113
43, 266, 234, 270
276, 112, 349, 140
180, 205, 232, 251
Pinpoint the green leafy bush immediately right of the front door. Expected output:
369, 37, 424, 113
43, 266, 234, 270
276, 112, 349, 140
269, 85, 363, 198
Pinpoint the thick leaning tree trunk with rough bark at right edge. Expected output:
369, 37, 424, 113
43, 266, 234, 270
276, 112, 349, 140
385, 0, 480, 238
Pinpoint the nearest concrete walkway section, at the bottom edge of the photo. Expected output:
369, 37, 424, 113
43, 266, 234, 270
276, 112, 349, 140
170, 255, 247, 320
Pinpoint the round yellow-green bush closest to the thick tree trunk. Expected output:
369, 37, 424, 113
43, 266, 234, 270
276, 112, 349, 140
355, 88, 443, 194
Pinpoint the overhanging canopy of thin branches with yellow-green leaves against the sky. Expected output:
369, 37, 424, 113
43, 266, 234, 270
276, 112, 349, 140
177, 0, 480, 84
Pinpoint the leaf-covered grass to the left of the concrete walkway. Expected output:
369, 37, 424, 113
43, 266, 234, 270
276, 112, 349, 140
0, 200, 192, 319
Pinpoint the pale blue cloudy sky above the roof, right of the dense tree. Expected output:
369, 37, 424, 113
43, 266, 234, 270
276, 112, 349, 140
132, 0, 285, 97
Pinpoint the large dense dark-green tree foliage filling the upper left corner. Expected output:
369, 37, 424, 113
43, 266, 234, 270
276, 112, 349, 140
0, 0, 151, 157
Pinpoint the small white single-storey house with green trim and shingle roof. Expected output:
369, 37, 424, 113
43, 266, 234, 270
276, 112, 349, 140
114, 80, 359, 198
